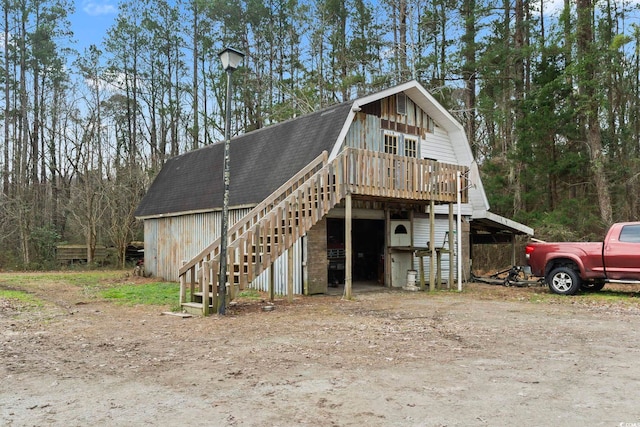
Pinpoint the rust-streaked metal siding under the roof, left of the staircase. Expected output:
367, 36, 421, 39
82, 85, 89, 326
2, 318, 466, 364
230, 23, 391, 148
144, 208, 250, 281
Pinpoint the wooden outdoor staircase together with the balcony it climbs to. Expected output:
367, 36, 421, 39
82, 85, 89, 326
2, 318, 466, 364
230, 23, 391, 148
179, 148, 467, 315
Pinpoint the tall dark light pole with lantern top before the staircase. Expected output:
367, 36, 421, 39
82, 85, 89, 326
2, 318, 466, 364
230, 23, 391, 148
217, 47, 244, 314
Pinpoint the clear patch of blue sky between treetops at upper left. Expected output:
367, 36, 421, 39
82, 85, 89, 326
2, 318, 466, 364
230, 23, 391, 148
70, 0, 118, 52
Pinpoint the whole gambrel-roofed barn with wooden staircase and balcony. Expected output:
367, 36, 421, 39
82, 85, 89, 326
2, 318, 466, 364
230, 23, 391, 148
136, 81, 533, 313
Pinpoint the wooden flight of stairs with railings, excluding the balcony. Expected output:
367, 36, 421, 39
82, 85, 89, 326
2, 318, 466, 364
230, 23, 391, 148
179, 152, 345, 315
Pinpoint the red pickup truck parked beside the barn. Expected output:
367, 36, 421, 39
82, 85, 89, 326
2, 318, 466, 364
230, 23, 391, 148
525, 222, 640, 295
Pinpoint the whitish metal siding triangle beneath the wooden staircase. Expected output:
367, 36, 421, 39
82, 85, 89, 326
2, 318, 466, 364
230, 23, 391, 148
249, 237, 304, 295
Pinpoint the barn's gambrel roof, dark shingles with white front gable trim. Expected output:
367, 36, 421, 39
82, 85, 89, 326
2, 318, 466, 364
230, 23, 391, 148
135, 80, 533, 234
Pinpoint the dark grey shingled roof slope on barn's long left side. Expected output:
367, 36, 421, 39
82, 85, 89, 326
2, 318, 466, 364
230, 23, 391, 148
135, 102, 352, 218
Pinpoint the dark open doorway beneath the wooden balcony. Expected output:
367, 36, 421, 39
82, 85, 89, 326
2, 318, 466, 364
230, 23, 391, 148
327, 218, 385, 287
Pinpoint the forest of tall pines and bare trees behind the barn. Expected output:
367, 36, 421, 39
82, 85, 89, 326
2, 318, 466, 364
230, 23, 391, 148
0, 0, 640, 268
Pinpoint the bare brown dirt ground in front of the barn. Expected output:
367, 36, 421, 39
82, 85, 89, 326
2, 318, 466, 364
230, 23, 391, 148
0, 275, 640, 426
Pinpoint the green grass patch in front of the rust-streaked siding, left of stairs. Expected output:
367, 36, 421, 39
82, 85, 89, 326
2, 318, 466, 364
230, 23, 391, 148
100, 282, 180, 306
